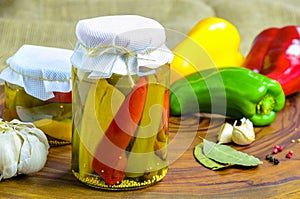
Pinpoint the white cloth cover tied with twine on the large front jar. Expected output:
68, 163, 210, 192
71, 15, 173, 78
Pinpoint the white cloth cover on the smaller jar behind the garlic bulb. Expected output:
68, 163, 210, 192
0, 45, 73, 100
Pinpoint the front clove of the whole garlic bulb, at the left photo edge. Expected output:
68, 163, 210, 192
0, 131, 21, 181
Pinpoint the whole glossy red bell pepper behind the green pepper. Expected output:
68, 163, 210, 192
243, 26, 300, 96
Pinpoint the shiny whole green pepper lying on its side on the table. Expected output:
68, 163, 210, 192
170, 67, 285, 126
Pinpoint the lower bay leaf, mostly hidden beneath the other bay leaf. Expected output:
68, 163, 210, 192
194, 143, 229, 170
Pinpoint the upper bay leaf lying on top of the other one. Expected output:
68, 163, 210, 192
203, 139, 262, 166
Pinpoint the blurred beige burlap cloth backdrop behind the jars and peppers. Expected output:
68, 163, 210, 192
0, 0, 300, 70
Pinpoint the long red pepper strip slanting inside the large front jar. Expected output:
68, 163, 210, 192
93, 77, 147, 185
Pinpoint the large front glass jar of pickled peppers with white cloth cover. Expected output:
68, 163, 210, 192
71, 15, 173, 190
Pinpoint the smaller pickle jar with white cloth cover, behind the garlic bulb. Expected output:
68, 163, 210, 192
0, 45, 73, 146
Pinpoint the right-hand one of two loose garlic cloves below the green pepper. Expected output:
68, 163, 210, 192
231, 118, 255, 145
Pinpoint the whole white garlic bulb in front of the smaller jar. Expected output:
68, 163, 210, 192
0, 119, 49, 181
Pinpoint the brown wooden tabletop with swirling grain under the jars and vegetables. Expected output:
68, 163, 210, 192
0, 84, 300, 199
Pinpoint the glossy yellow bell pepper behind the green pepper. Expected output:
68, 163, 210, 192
170, 17, 244, 82
